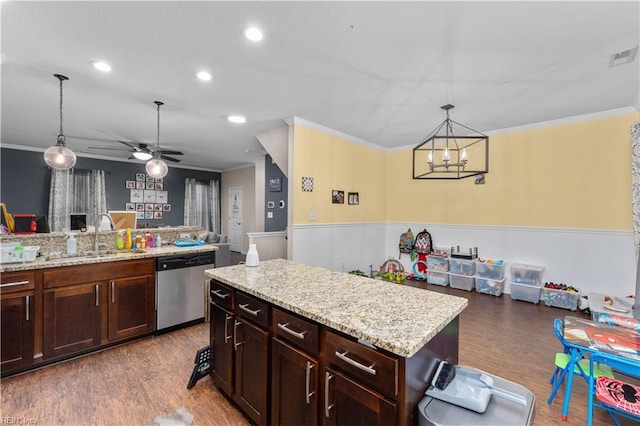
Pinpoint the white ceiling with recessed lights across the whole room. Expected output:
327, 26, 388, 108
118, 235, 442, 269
0, 1, 640, 171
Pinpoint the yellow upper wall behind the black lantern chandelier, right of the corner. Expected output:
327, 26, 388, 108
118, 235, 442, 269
386, 113, 640, 230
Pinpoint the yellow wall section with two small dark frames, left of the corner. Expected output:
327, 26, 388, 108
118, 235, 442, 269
289, 124, 387, 224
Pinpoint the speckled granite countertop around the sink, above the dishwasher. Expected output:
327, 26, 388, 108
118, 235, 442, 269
0, 244, 218, 272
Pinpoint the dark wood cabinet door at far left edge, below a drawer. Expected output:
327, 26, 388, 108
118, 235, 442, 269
0, 293, 34, 375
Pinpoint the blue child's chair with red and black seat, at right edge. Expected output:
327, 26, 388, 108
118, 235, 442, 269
587, 352, 640, 426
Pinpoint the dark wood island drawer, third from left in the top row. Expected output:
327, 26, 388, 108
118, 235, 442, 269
271, 308, 319, 355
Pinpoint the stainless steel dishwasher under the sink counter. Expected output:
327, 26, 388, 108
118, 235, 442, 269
156, 252, 215, 333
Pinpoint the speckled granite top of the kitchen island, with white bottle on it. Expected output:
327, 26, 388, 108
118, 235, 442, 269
205, 259, 468, 358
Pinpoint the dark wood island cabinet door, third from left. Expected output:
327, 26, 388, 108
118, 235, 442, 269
271, 339, 318, 426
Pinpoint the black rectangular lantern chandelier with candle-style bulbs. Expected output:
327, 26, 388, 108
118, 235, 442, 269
413, 104, 489, 179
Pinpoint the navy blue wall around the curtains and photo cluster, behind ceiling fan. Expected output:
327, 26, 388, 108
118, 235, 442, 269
0, 148, 221, 227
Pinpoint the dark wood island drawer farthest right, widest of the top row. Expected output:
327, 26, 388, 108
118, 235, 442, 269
325, 331, 398, 397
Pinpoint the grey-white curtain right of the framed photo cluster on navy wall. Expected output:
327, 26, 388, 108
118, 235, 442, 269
184, 178, 220, 233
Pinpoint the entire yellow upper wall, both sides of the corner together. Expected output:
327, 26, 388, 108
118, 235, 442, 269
290, 112, 640, 230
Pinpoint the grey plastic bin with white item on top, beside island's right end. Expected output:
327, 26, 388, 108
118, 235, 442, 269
418, 361, 535, 426
